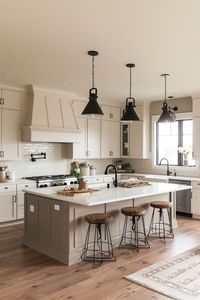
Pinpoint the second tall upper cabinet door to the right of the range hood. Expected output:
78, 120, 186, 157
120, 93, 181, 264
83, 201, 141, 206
88, 119, 101, 158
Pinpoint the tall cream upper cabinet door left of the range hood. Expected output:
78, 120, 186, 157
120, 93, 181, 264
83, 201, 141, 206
2, 109, 21, 160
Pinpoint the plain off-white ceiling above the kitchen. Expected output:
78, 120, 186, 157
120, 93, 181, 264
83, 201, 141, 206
0, 0, 200, 101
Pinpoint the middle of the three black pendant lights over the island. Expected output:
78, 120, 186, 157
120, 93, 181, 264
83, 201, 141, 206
121, 63, 140, 123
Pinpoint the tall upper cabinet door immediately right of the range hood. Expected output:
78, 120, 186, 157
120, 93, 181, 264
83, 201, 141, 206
73, 118, 87, 159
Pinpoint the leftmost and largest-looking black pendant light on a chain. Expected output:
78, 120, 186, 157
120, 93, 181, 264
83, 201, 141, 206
82, 50, 103, 116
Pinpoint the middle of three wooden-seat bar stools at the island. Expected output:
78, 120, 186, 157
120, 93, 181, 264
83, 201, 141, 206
120, 207, 150, 252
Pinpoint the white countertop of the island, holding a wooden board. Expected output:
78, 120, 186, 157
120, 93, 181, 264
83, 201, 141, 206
24, 182, 191, 206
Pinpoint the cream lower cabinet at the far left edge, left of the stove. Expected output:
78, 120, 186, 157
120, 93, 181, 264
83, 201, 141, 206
0, 184, 16, 222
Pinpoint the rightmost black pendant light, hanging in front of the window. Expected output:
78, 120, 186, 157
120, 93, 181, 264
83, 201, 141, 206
158, 74, 178, 123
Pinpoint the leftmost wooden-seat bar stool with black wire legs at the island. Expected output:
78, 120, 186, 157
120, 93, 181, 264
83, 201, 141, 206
81, 213, 116, 264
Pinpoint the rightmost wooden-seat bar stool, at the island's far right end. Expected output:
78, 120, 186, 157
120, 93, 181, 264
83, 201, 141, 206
148, 201, 174, 241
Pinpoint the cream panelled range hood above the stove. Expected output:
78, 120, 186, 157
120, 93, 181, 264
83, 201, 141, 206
22, 86, 80, 143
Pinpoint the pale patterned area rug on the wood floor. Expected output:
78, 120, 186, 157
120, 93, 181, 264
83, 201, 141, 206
125, 246, 200, 300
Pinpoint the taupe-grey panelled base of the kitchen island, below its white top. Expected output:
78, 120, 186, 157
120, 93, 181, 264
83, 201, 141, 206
23, 192, 175, 265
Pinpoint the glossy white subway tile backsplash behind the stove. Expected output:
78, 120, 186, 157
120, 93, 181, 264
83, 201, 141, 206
0, 143, 112, 178
